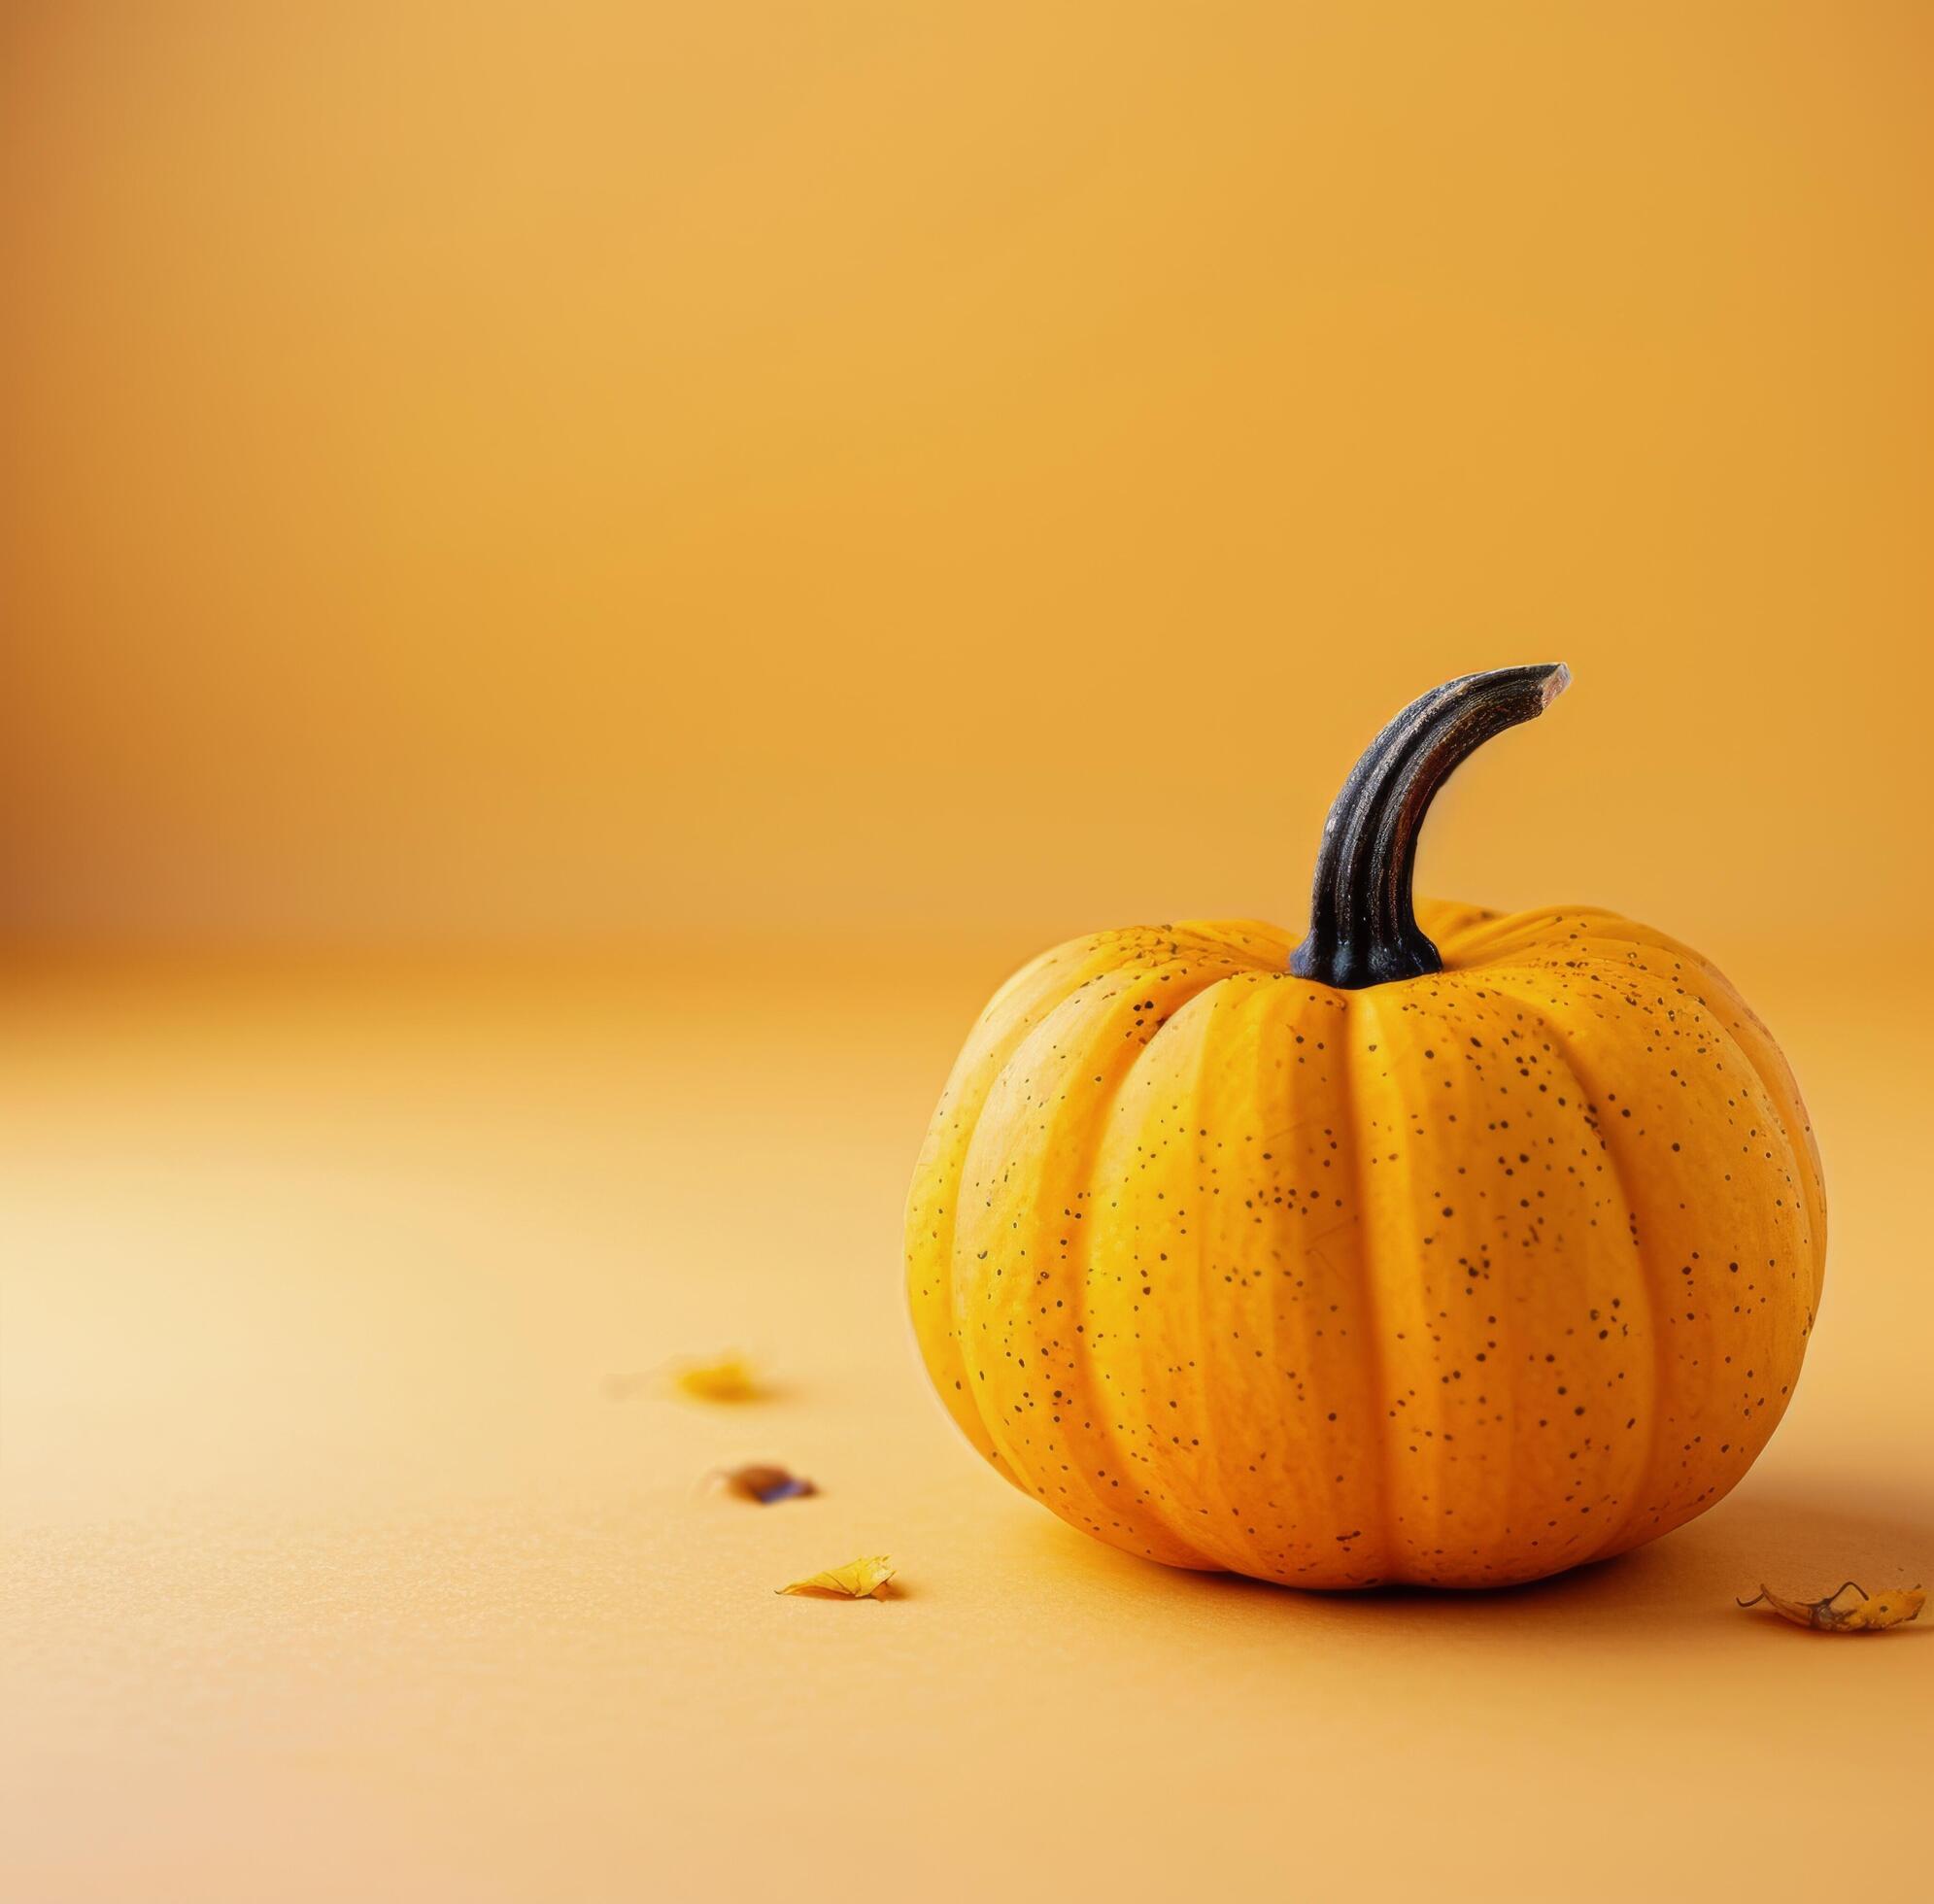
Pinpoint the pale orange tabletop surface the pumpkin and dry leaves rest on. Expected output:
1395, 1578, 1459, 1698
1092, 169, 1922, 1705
0, 948, 1934, 1904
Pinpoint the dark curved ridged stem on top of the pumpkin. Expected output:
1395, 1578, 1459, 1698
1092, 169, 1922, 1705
1290, 663, 1571, 991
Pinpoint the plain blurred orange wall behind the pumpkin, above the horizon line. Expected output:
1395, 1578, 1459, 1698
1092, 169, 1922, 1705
0, 0, 1934, 962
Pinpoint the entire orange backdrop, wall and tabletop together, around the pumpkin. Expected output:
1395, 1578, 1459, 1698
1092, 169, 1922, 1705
0, 11, 1934, 1900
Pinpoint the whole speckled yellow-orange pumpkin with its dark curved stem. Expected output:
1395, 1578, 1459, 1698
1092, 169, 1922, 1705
907, 667, 1826, 1588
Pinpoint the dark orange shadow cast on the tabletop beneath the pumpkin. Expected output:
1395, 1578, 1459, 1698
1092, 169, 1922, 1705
1038, 1480, 1934, 1645
